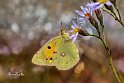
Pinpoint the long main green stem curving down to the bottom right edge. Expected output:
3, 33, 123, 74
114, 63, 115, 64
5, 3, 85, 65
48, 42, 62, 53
90, 34, 122, 83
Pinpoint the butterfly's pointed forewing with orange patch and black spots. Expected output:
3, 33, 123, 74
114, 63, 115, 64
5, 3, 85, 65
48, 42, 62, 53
32, 36, 59, 66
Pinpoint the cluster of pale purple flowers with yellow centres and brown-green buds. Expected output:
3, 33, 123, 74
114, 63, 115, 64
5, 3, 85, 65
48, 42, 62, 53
69, 0, 112, 43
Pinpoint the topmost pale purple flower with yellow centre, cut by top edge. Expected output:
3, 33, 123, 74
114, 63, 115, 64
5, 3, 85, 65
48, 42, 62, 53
86, 0, 112, 10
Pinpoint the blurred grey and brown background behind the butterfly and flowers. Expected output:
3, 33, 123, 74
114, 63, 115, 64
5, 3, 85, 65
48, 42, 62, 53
0, 0, 124, 83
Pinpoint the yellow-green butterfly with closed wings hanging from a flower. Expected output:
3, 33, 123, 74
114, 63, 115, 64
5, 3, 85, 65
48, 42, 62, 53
32, 29, 79, 70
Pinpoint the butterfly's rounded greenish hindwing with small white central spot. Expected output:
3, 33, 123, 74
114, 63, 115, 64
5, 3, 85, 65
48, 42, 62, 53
54, 34, 79, 70
